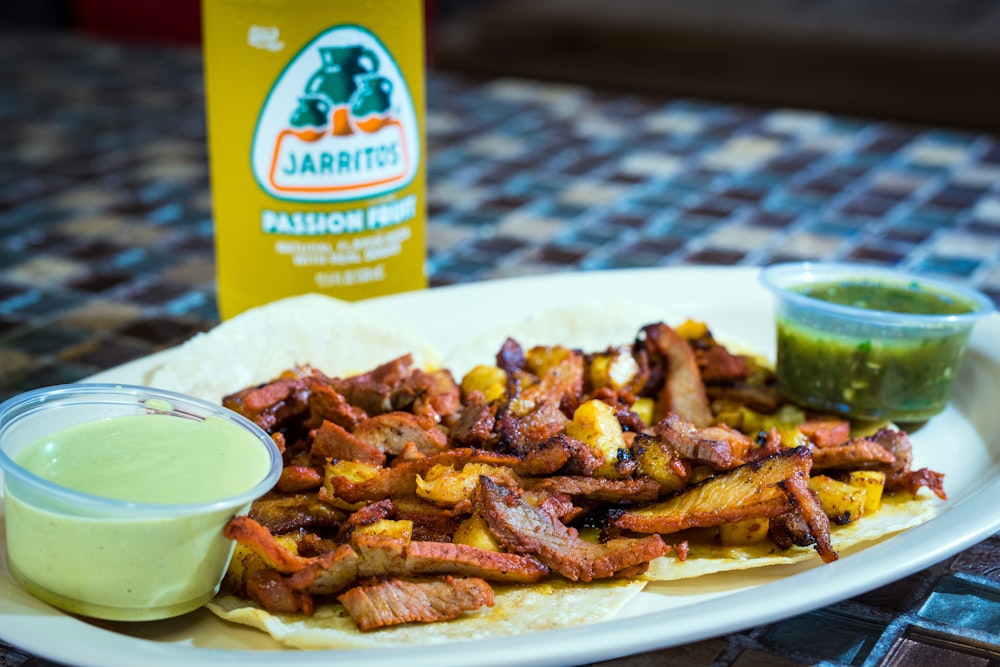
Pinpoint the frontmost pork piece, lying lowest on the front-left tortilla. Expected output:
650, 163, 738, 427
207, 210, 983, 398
337, 577, 495, 632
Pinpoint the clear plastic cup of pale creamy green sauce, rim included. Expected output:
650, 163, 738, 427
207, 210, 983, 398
0, 384, 282, 620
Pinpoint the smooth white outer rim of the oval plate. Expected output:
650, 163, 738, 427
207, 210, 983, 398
0, 266, 1000, 667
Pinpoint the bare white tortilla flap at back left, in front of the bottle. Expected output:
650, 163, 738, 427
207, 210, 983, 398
147, 294, 439, 403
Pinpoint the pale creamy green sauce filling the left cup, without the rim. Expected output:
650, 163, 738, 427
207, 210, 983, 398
4, 414, 270, 620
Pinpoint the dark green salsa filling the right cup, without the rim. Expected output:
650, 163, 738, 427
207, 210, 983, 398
777, 281, 978, 421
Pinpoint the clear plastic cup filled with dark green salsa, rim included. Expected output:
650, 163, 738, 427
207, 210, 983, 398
760, 262, 995, 422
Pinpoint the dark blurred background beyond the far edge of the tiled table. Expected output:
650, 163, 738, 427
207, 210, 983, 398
7, 0, 1000, 130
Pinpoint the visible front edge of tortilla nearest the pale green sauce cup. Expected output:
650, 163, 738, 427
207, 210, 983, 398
208, 579, 645, 649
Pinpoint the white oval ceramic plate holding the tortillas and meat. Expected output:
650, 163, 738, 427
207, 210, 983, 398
0, 268, 1000, 667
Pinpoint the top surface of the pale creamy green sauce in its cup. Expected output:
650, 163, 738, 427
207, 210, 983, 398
14, 414, 268, 504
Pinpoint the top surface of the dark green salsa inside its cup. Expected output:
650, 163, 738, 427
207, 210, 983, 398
793, 280, 977, 315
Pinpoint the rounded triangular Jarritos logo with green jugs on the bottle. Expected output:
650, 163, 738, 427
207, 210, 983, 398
252, 25, 420, 201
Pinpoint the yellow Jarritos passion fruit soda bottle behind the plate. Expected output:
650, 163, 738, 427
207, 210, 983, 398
202, 0, 427, 319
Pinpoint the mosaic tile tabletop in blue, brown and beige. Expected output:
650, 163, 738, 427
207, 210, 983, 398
0, 28, 1000, 667
